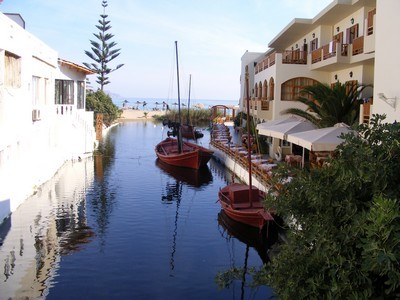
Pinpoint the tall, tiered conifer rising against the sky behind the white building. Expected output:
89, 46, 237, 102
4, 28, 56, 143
83, 0, 123, 91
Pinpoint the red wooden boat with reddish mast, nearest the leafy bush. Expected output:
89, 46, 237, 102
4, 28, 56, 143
218, 68, 274, 230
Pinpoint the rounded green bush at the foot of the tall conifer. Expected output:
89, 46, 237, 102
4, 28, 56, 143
86, 90, 122, 126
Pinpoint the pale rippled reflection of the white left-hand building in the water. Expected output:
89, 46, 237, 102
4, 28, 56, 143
0, 159, 94, 299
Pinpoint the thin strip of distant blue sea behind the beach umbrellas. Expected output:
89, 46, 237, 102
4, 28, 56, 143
110, 95, 239, 110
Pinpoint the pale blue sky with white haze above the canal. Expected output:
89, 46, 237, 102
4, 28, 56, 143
0, 0, 332, 100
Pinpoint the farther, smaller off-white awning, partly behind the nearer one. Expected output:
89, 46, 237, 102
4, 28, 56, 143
258, 119, 317, 140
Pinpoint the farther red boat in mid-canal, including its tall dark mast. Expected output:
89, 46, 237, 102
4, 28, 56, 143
155, 42, 214, 169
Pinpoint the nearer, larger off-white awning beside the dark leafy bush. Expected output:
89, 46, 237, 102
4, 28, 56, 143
286, 123, 354, 151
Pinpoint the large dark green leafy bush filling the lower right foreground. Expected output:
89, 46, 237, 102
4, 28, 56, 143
266, 115, 400, 299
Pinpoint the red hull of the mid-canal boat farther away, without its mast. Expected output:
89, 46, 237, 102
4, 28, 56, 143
155, 137, 214, 169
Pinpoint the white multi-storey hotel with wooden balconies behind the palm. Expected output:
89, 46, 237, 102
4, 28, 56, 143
240, 0, 400, 159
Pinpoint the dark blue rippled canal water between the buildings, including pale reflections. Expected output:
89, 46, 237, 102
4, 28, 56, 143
0, 121, 272, 299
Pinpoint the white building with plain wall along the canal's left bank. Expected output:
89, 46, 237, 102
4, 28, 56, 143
0, 13, 96, 223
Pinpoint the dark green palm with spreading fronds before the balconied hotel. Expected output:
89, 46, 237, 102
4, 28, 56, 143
282, 82, 371, 128
